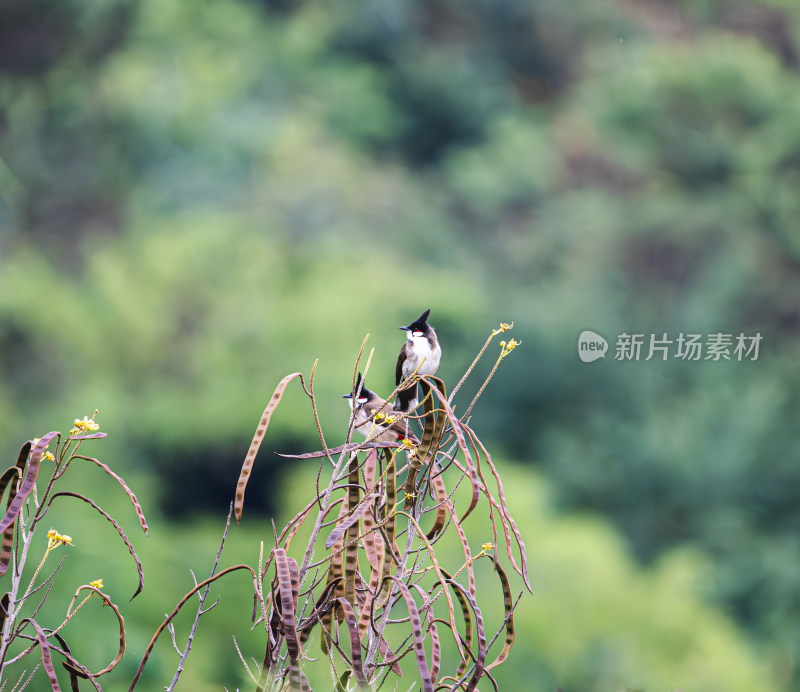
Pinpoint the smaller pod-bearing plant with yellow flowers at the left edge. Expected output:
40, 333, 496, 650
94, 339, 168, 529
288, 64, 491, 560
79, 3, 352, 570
0, 411, 147, 690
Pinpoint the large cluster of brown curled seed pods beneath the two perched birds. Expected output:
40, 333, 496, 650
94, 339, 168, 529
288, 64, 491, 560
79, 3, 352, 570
222, 324, 530, 692
